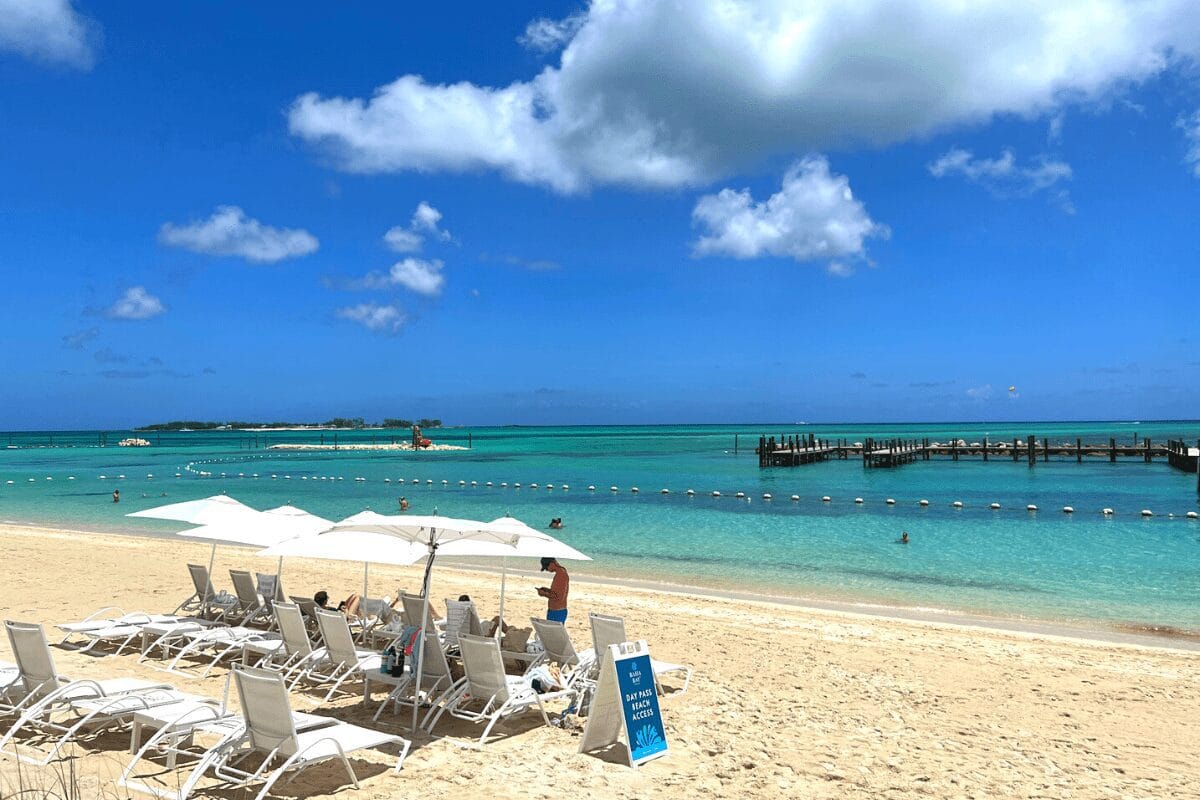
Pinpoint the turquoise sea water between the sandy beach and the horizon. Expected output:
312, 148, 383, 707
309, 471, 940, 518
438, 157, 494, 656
0, 422, 1200, 628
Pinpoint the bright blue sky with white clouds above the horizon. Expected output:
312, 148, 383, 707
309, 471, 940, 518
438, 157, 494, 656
0, 0, 1200, 429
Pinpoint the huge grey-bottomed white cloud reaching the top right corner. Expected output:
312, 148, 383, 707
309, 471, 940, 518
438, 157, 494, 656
288, 0, 1200, 192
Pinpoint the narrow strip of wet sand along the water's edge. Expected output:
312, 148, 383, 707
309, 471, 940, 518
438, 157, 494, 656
9, 519, 1200, 652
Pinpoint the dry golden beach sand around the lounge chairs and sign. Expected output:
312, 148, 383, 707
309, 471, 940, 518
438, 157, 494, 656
0, 527, 1200, 800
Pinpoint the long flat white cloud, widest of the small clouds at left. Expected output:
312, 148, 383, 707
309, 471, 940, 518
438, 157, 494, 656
158, 205, 320, 264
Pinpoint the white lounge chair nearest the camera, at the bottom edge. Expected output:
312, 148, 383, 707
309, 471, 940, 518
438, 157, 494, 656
121, 667, 410, 800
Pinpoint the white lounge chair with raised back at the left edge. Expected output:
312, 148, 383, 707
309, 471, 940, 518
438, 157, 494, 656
0, 620, 190, 765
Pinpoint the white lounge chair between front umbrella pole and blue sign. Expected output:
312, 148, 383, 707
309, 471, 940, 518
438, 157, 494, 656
426, 633, 576, 747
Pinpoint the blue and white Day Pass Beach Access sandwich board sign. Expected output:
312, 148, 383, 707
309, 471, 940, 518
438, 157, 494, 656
580, 640, 667, 766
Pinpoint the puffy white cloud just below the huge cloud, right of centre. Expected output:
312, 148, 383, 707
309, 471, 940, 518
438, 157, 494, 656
691, 156, 888, 268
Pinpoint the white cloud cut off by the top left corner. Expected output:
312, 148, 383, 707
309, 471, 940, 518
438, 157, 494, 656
0, 0, 98, 70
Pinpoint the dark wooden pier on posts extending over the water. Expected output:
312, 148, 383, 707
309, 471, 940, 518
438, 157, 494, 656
756, 433, 1200, 492
